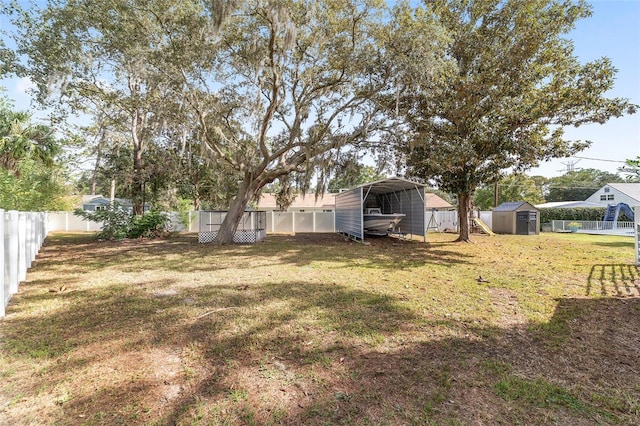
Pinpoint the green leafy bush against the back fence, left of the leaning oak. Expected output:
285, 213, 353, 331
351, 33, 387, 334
74, 205, 169, 240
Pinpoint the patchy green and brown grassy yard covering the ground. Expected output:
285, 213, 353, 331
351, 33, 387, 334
0, 234, 640, 425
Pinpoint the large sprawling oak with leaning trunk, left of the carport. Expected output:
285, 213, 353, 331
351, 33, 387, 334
168, 0, 432, 244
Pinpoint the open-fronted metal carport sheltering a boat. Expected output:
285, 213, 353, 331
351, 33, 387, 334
335, 177, 426, 241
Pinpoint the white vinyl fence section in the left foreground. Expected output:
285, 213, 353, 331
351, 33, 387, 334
0, 209, 47, 317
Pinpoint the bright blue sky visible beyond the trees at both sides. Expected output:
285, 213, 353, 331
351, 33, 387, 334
0, 0, 640, 177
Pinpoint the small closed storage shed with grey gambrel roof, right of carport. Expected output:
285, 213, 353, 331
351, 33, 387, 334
492, 201, 540, 235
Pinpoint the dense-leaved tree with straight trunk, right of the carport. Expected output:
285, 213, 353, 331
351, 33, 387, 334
400, 0, 636, 241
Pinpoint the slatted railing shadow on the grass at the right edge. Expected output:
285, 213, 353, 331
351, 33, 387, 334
586, 263, 640, 297
